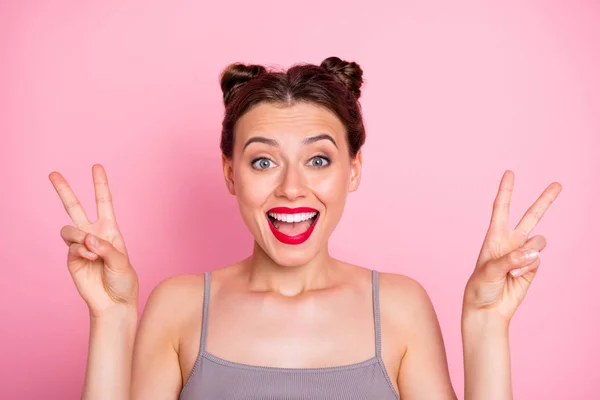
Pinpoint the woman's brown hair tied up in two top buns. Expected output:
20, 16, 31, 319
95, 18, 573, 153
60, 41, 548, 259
221, 57, 365, 158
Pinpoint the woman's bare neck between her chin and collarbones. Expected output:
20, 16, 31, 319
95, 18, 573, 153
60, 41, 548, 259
245, 242, 336, 297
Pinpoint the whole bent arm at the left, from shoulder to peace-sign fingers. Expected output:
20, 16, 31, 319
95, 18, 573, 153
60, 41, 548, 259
49, 165, 199, 400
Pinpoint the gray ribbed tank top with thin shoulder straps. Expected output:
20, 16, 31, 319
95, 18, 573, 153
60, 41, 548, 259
179, 271, 400, 400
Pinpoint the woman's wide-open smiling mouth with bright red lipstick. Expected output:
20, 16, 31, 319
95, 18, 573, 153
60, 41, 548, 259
266, 207, 320, 244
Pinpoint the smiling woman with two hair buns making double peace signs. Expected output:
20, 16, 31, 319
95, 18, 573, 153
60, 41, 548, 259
50, 57, 561, 400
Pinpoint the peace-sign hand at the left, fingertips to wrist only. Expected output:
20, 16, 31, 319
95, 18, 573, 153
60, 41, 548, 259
49, 165, 138, 316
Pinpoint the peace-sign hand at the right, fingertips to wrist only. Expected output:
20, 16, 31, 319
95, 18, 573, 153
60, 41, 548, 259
463, 171, 562, 322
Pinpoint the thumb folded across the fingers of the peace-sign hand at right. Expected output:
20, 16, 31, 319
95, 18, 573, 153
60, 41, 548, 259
484, 236, 546, 280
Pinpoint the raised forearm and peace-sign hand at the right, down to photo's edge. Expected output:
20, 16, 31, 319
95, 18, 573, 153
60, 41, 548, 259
462, 171, 562, 400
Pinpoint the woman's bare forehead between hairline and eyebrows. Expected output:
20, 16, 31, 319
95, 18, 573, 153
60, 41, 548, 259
235, 102, 345, 142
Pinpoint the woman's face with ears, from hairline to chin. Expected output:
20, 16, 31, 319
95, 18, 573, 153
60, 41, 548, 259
223, 103, 361, 266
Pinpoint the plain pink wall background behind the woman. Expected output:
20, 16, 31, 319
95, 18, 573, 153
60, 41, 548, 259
0, 0, 600, 399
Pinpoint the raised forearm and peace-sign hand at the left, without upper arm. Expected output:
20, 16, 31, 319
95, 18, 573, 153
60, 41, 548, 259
48, 165, 138, 400
